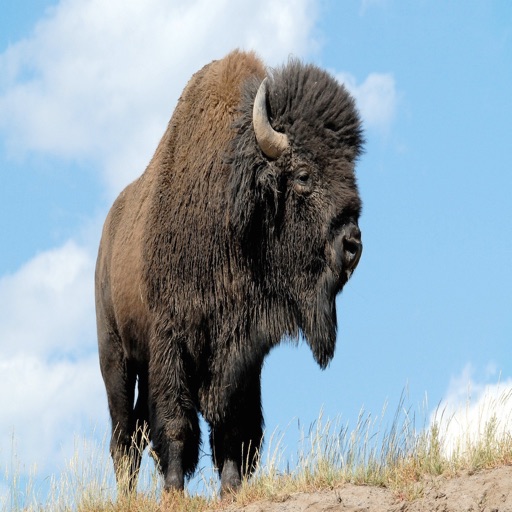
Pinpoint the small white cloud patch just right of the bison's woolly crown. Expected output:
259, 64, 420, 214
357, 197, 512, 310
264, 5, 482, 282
337, 73, 398, 134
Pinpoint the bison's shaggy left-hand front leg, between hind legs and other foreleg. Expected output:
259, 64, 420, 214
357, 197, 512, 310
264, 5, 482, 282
149, 344, 201, 491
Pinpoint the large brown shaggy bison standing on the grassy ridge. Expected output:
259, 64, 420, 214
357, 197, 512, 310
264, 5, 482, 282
95, 51, 364, 492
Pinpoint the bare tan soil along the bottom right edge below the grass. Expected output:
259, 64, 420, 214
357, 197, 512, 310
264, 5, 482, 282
224, 466, 512, 512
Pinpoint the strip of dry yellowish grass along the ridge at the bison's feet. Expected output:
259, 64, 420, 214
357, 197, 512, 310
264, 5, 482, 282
4, 395, 512, 512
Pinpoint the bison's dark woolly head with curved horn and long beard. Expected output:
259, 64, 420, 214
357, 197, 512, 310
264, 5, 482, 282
231, 61, 363, 367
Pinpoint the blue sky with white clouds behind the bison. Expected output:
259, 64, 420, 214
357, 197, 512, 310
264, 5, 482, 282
0, 0, 512, 504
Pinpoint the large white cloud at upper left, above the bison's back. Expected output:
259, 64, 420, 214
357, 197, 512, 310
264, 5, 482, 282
0, 0, 318, 192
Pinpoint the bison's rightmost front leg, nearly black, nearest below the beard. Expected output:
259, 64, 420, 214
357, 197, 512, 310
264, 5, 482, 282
210, 371, 263, 494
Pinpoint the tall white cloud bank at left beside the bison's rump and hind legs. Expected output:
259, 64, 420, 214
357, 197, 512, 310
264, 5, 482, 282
0, 241, 107, 480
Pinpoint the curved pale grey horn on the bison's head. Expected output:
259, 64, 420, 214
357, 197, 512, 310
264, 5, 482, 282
252, 78, 288, 158
